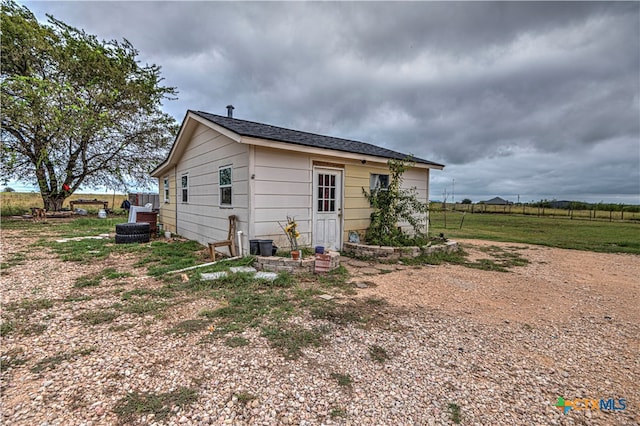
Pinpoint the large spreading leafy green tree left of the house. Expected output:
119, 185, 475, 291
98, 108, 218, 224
0, 0, 177, 210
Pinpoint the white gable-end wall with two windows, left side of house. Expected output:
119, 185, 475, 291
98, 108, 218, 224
172, 125, 249, 252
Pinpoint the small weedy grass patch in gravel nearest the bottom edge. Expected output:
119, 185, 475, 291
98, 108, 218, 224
113, 387, 198, 424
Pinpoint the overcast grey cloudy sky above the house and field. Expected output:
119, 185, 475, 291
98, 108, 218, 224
20, 1, 640, 204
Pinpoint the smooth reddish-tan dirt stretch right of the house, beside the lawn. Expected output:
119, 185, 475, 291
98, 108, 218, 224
349, 240, 640, 325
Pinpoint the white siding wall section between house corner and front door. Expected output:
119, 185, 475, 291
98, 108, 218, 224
251, 147, 313, 250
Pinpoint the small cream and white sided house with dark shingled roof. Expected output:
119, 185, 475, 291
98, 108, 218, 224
151, 106, 444, 254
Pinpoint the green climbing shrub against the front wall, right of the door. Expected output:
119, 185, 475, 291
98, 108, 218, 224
362, 160, 428, 246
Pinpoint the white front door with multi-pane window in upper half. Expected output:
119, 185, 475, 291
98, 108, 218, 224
313, 167, 342, 250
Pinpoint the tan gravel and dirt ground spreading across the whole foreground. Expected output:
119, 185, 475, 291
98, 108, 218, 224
0, 226, 640, 425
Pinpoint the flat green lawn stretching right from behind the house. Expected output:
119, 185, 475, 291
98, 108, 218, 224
429, 211, 640, 254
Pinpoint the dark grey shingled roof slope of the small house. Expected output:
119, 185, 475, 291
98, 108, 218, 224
190, 110, 444, 167
